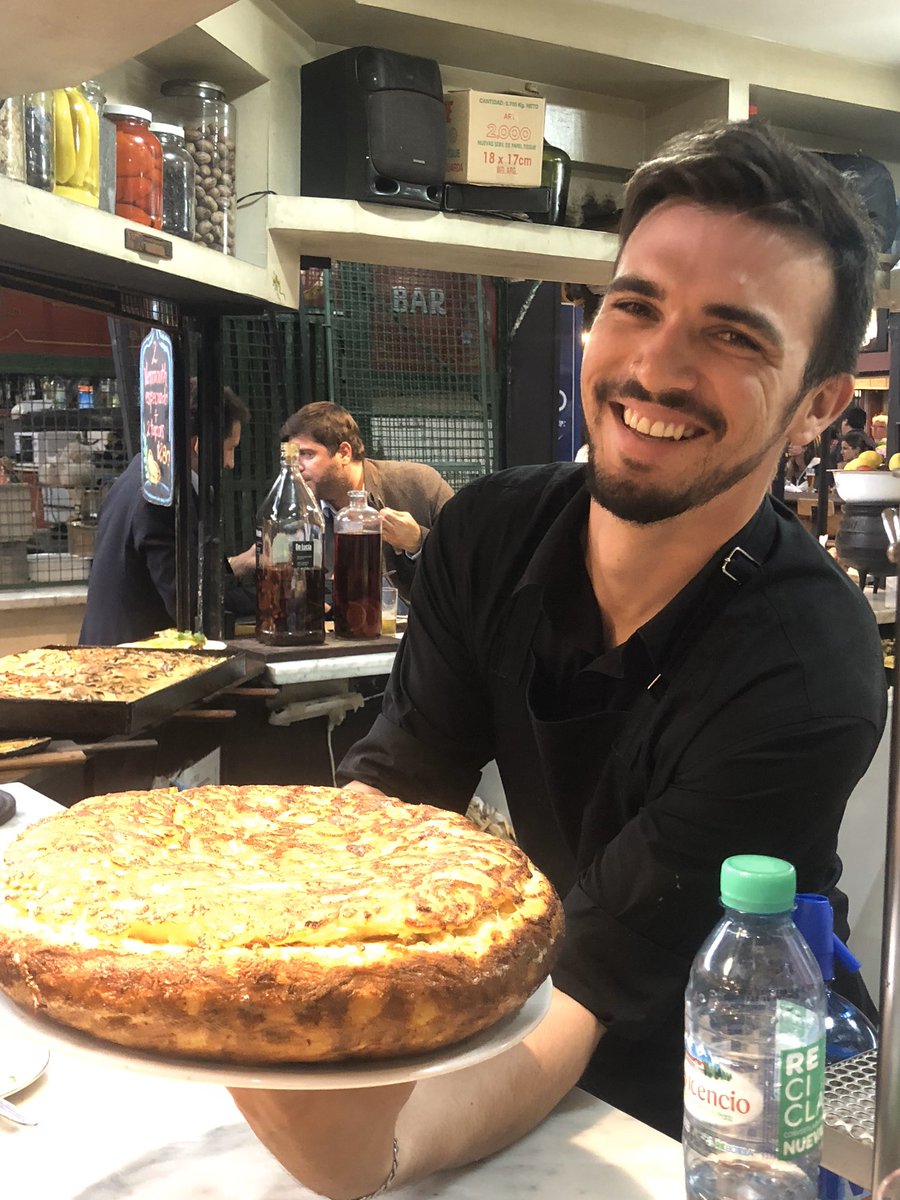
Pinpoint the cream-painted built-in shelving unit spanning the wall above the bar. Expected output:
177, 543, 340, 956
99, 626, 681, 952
8, 0, 900, 312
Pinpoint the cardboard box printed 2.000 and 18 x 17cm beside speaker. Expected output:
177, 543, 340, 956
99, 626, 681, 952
444, 89, 544, 187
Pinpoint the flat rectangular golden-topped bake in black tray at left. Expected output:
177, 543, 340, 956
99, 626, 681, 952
0, 646, 226, 702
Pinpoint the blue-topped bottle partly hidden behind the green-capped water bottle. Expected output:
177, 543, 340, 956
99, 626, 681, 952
793, 893, 878, 1200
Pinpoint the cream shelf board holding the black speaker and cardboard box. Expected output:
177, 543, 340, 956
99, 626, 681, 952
268, 196, 617, 291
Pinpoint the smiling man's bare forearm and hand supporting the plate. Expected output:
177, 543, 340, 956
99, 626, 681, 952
233, 992, 601, 1200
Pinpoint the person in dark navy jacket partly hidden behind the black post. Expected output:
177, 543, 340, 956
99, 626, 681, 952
78, 388, 256, 646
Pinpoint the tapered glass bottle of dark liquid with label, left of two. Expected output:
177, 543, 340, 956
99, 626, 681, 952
257, 442, 325, 646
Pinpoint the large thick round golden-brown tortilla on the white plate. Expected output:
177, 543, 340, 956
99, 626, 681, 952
0, 786, 563, 1063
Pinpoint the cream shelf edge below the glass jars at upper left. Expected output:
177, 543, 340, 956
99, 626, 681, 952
0, 176, 284, 312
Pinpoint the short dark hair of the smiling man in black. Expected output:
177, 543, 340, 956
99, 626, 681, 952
619, 118, 877, 388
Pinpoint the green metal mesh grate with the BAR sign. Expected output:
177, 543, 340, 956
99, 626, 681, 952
223, 263, 500, 553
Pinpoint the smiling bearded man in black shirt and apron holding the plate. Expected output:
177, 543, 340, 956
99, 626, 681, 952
233, 121, 887, 1196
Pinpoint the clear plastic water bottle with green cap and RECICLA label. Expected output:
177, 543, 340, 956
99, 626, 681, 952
683, 854, 826, 1200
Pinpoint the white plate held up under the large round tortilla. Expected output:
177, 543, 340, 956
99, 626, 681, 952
0, 979, 553, 1092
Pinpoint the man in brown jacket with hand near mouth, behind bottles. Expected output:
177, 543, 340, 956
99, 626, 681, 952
281, 401, 454, 602
